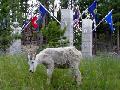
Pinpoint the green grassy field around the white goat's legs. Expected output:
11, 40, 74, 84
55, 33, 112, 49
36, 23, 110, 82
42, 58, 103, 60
0, 55, 120, 90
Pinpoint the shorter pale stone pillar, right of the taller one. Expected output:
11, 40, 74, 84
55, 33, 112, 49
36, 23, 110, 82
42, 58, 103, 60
82, 19, 93, 57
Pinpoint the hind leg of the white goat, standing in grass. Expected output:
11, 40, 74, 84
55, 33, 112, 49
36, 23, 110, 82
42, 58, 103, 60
72, 65, 81, 85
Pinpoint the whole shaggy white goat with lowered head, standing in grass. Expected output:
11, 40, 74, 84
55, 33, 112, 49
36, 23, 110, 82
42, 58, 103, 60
28, 47, 82, 85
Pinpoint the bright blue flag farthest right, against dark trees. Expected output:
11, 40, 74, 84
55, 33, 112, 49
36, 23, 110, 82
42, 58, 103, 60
105, 10, 115, 32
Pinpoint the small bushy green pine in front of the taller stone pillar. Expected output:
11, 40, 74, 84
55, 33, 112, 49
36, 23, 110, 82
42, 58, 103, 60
41, 21, 67, 47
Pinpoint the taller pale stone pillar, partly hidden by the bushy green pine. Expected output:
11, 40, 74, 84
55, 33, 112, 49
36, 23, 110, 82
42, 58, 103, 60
61, 9, 73, 46
